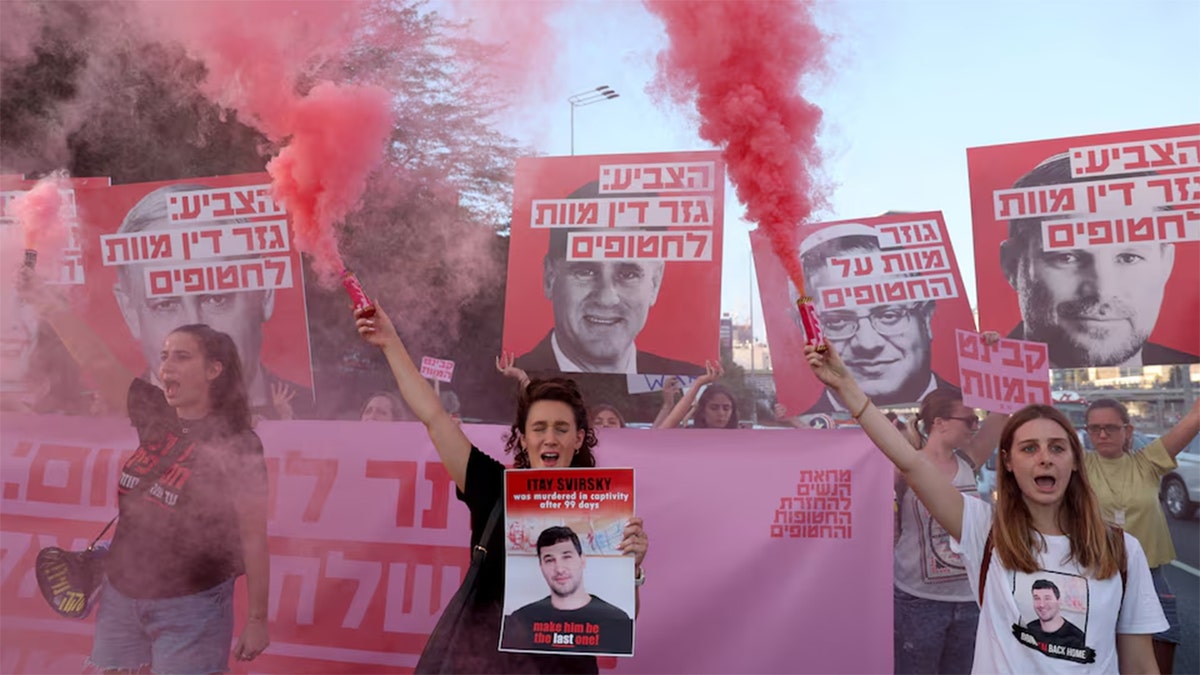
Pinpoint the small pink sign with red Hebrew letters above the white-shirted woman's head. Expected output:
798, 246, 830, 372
954, 330, 1052, 414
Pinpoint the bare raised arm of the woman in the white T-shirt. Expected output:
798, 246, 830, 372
804, 341, 962, 539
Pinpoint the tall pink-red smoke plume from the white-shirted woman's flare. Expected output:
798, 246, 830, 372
646, 0, 826, 293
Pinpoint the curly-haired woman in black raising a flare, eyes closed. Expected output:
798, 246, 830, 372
355, 305, 649, 673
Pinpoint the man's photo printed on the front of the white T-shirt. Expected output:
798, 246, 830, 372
1013, 569, 1096, 663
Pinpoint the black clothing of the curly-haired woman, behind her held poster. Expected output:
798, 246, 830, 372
454, 447, 600, 673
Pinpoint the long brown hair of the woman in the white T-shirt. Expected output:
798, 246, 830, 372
991, 405, 1124, 579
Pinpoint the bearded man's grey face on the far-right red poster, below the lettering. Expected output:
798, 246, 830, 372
1006, 237, 1175, 368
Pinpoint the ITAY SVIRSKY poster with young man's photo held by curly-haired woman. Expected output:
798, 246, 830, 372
499, 468, 636, 656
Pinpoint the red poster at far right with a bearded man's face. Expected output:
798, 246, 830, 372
967, 125, 1200, 368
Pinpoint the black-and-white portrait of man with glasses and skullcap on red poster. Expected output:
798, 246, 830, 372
792, 223, 952, 414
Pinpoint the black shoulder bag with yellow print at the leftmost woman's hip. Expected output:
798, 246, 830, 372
34, 429, 190, 619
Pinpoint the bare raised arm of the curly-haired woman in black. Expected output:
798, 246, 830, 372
354, 304, 470, 490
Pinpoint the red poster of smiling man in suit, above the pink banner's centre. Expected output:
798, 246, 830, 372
504, 151, 725, 375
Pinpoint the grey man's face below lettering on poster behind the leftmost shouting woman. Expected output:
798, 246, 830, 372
114, 267, 275, 378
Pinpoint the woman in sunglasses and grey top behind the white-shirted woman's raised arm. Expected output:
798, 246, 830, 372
893, 381, 1008, 674
